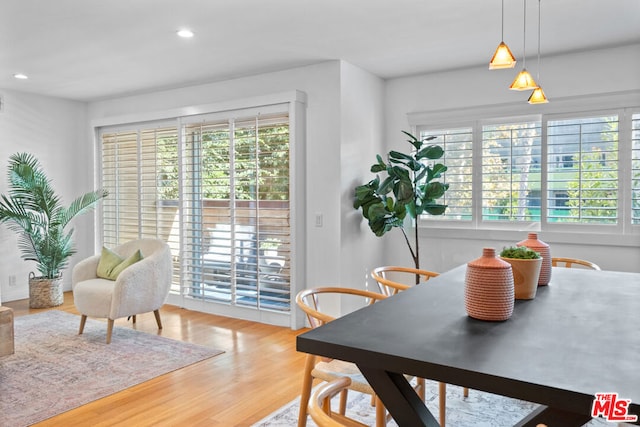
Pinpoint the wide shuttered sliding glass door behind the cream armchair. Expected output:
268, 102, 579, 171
99, 112, 291, 312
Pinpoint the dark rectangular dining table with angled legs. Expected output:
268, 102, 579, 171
297, 265, 640, 427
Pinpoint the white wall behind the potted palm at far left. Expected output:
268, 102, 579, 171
0, 89, 93, 301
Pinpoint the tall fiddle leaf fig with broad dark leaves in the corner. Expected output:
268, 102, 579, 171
353, 131, 449, 283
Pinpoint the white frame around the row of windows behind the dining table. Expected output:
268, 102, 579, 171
407, 91, 640, 246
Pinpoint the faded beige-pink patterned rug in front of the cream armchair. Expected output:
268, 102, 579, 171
0, 310, 223, 427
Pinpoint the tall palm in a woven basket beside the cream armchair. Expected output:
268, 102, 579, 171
0, 153, 107, 308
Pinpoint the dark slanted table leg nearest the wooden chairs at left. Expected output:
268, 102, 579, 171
358, 365, 440, 427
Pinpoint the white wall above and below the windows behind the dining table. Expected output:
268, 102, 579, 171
385, 45, 640, 272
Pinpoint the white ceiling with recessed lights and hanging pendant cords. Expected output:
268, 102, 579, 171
0, 0, 640, 101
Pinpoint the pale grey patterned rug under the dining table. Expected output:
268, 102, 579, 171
252, 381, 611, 427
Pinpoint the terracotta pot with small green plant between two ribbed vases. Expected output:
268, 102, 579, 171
500, 246, 542, 299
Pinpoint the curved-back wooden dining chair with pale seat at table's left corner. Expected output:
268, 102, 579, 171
296, 287, 424, 427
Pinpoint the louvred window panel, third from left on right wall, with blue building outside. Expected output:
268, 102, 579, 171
547, 115, 618, 224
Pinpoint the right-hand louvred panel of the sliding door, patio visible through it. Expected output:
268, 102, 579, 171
182, 114, 291, 311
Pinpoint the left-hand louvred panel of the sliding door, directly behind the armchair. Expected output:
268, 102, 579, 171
101, 126, 179, 290
